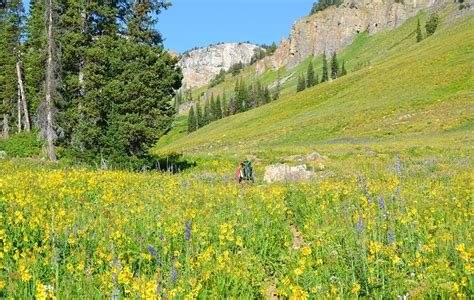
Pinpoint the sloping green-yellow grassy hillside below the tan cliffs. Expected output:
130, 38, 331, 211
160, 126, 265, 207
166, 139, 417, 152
157, 6, 474, 157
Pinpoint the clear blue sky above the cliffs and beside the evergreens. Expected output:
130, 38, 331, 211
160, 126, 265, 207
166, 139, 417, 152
157, 0, 314, 53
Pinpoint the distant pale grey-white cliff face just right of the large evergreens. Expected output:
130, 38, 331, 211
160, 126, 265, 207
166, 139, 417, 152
179, 43, 260, 88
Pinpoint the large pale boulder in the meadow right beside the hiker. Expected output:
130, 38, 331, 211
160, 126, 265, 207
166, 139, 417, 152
263, 164, 314, 183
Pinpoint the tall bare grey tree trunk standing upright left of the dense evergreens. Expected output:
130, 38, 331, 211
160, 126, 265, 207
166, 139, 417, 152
45, 0, 56, 161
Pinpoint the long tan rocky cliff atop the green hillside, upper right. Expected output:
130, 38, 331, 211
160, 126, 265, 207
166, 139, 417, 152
257, 0, 446, 74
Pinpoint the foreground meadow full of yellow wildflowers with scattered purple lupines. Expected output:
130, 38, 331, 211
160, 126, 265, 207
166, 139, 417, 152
0, 152, 474, 299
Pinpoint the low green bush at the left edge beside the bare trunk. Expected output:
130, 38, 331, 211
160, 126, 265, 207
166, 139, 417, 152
0, 132, 43, 157
